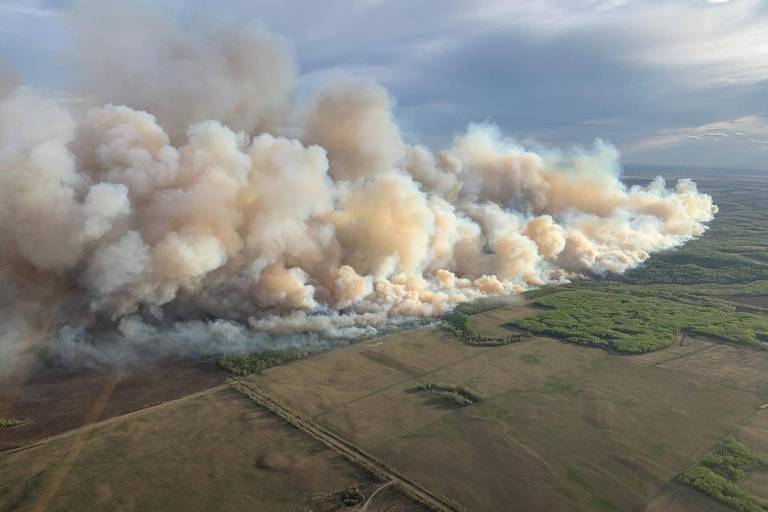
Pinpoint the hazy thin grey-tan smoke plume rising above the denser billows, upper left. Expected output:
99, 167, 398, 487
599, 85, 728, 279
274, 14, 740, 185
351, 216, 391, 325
73, 0, 296, 141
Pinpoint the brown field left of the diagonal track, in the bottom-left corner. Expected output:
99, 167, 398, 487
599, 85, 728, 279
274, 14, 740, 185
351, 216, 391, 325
0, 388, 421, 512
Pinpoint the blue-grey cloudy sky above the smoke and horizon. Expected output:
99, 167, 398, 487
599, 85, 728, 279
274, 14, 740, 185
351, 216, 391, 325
0, 0, 768, 169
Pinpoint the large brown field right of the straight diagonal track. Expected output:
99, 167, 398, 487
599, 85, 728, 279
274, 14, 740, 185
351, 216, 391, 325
249, 308, 768, 511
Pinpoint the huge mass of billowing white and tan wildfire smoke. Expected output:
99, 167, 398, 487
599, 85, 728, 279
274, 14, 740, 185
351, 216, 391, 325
0, 3, 717, 369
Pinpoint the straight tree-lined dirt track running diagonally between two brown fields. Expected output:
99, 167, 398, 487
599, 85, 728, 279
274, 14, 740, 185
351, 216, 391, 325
230, 379, 466, 512
